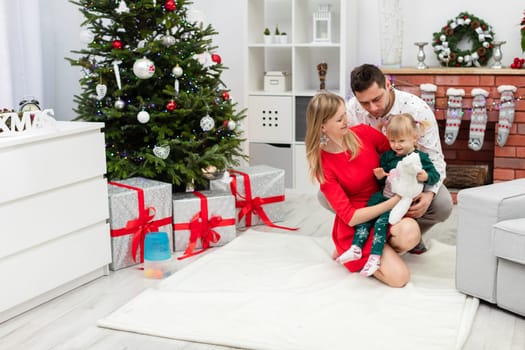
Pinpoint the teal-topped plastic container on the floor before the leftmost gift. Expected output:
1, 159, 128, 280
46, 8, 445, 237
144, 232, 171, 278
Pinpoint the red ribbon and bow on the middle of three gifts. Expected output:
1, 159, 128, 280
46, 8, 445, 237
173, 191, 235, 260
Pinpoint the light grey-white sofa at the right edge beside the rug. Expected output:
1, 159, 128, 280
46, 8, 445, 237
456, 179, 525, 316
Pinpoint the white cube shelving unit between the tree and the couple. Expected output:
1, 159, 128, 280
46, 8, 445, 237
246, 0, 347, 192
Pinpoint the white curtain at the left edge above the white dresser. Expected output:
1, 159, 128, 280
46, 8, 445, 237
0, 0, 44, 110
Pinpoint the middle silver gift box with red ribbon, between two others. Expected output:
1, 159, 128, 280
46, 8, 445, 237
173, 190, 237, 251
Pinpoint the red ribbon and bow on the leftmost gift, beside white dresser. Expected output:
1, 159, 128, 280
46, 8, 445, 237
109, 182, 172, 262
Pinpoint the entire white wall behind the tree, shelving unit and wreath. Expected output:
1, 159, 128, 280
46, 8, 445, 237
46, 0, 525, 120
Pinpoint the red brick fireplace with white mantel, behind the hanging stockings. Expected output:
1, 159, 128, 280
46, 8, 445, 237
383, 68, 525, 190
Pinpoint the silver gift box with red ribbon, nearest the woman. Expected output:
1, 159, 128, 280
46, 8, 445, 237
210, 165, 284, 228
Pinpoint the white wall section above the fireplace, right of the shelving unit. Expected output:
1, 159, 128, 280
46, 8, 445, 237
352, 0, 525, 67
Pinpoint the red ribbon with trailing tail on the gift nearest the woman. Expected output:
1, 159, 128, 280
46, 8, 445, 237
229, 169, 297, 231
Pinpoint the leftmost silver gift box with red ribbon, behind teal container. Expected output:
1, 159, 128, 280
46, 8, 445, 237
108, 177, 173, 271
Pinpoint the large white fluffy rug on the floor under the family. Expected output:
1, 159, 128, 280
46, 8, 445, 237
99, 230, 478, 350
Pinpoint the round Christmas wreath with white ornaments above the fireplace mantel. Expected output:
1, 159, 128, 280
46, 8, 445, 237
432, 12, 494, 67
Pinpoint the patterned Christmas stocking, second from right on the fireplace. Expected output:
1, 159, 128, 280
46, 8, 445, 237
468, 88, 489, 151
